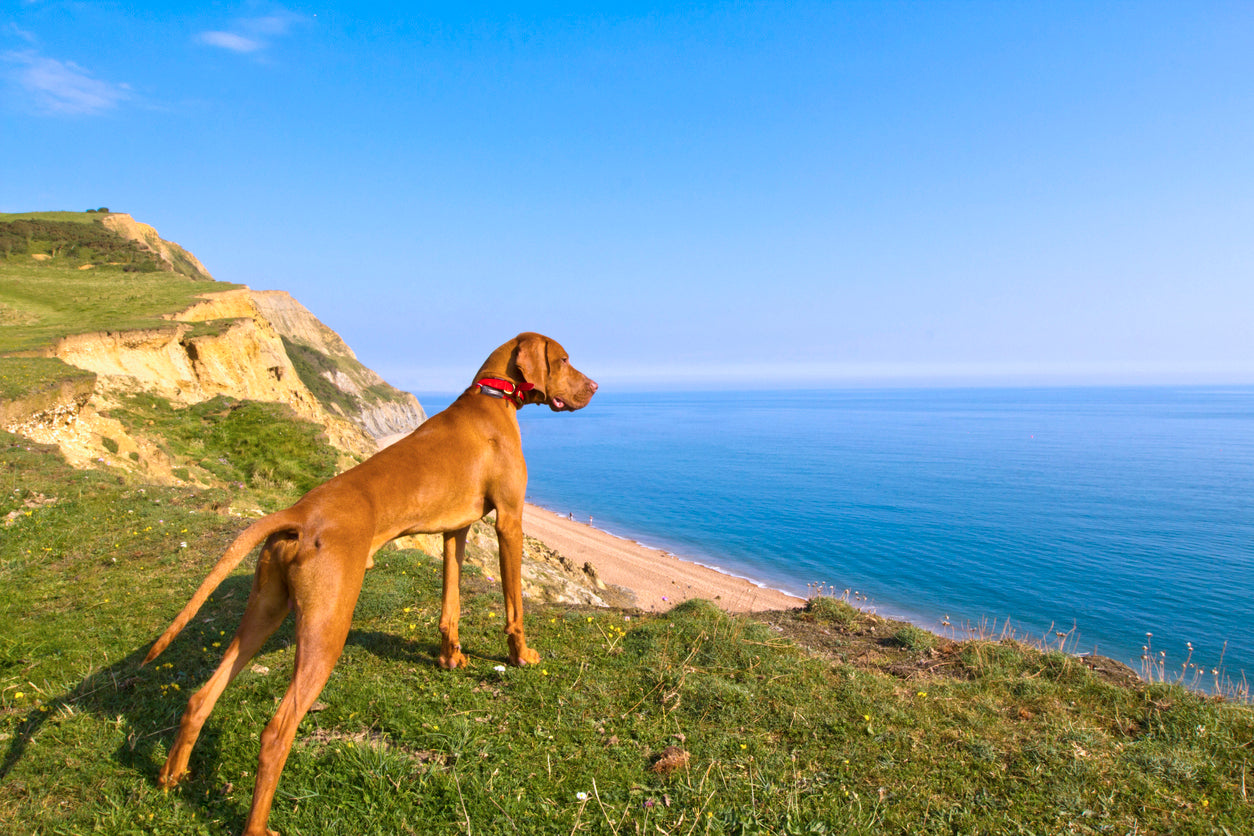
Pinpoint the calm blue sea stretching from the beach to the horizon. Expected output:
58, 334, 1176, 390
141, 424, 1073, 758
426, 387, 1254, 689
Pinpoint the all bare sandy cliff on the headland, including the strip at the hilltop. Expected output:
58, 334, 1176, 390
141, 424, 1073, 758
0, 219, 426, 476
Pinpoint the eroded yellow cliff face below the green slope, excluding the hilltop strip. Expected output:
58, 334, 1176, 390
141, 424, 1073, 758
6, 288, 425, 479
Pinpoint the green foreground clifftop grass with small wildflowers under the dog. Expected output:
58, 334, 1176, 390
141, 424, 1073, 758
0, 418, 1254, 835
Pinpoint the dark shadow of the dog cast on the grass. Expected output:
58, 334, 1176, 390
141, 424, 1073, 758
0, 575, 474, 830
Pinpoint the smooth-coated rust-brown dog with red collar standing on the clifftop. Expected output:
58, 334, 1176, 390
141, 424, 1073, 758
144, 333, 597, 836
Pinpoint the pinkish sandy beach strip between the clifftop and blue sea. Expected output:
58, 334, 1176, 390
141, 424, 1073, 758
523, 505, 805, 613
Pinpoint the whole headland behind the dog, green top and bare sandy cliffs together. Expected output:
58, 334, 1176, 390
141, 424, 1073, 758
0, 213, 425, 479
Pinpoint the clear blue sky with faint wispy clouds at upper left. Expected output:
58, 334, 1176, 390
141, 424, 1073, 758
0, 0, 1254, 392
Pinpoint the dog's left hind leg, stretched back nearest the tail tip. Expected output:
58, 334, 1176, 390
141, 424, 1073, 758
157, 544, 288, 787
